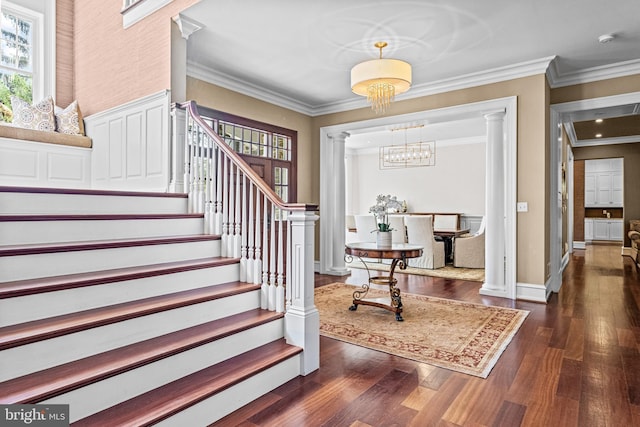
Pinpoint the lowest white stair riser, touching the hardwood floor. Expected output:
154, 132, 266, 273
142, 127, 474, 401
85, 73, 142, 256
154, 354, 301, 427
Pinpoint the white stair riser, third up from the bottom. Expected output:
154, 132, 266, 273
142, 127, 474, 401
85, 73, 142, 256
0, 291, 260, 381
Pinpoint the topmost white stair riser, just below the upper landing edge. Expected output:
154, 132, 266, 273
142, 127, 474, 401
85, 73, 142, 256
0, 191, 188, 215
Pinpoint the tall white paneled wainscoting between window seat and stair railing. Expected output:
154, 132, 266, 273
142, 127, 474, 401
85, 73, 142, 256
84, 90, 171, 192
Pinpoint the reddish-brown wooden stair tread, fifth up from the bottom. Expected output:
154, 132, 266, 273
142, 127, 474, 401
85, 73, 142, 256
0, 234, 220, 256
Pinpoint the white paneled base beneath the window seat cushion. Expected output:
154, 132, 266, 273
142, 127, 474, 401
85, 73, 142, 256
0, 137, 91, 188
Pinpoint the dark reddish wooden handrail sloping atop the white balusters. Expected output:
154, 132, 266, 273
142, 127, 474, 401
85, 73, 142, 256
176, 100, 318, 212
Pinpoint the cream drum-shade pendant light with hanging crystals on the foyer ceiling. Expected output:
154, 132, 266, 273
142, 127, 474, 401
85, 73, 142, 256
351, 42, 411, 114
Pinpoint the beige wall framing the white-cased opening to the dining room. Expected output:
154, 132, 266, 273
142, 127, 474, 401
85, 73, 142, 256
311, 75, 549, 284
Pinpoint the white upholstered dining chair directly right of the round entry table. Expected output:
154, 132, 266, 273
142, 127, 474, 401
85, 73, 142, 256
404, 215, 444, 269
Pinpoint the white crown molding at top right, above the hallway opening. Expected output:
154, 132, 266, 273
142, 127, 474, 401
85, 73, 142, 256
547, 59, 640, 88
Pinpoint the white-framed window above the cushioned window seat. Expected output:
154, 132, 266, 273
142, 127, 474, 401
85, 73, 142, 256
0, 0, 55, 121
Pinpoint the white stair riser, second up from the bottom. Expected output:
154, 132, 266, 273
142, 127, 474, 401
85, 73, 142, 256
41, 319, 284, 425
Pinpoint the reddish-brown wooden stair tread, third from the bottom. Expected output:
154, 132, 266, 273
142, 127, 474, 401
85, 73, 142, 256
0, 282, 260, 350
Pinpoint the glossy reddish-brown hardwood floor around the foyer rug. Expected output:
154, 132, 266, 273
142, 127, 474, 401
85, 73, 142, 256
215, 245, 640, 427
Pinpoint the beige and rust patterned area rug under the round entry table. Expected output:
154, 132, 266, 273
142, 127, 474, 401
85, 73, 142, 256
315, 283, 529, 378
